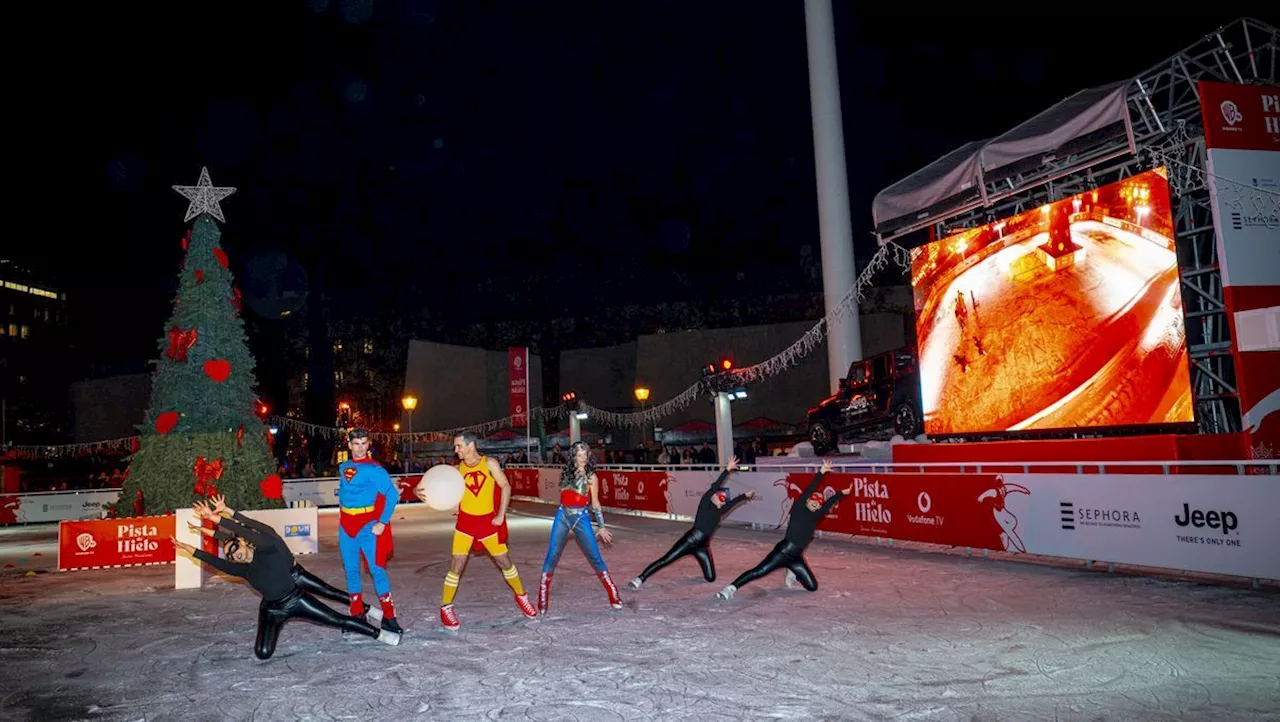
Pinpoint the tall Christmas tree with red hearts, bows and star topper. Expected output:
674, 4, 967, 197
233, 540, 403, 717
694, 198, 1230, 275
114, 169, 284, 516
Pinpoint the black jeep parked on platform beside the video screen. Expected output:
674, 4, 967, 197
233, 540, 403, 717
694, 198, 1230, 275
809, 348, 923, 454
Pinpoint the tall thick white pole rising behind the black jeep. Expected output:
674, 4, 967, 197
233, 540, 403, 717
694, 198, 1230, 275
804, 0, 863, 393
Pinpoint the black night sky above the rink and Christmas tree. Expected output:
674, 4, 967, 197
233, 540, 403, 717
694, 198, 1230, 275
5, 0, 1247, 371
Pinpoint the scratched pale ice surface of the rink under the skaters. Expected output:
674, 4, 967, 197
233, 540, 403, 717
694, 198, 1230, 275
0, 503, 1280, 722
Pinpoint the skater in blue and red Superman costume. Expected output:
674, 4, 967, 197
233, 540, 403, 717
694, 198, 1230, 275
338, 429, 404, 634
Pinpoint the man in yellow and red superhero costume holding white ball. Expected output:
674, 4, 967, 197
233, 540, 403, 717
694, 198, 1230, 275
440, 434, 538, 630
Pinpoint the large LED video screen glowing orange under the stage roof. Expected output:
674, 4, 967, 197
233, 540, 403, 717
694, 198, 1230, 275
911, 168, 1194, 435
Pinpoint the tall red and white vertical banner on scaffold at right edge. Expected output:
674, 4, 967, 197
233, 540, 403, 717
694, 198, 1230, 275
1198, 82, 1280, 453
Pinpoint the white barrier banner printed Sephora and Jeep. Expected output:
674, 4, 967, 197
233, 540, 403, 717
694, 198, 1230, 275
1004, 474, 1280, 579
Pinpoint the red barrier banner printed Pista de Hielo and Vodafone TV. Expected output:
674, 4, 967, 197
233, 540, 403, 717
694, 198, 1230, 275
787, 474, 1021, 550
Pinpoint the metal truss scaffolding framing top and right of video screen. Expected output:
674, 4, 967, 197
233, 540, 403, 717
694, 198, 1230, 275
868, 18, 1280, 433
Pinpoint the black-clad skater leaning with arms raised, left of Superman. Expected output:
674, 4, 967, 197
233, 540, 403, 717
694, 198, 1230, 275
173, 497, 399, 659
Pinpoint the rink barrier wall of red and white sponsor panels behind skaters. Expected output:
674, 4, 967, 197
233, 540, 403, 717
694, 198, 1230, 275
17, 457, 1280, 585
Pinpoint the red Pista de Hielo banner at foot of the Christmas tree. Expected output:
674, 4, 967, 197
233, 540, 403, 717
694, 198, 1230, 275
58, 515, 175, 571
